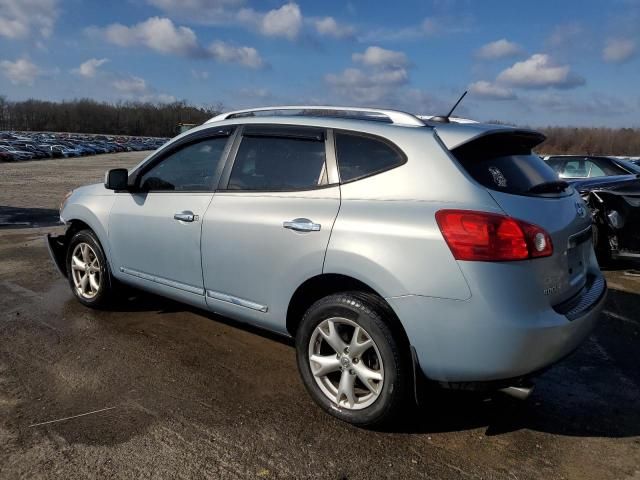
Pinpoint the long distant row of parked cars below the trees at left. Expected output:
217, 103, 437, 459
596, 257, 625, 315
0, 132, 168, 162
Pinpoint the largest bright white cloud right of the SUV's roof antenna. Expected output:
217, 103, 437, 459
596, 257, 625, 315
497, 53, 585, 89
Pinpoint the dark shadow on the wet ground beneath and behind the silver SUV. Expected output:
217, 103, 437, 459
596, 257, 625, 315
106, 284, 640, 438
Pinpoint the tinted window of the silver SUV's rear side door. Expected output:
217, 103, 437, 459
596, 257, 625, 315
227, 136, 326, 191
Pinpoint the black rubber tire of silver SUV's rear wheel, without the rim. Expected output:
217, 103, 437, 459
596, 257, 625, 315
296, 292, 412, 427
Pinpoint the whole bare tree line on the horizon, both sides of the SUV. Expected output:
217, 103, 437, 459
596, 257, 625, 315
0, 96, 640, 152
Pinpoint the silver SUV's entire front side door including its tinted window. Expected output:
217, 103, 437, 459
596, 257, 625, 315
109, 134, 229, 306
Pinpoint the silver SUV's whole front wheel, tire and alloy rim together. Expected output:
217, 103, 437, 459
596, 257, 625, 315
66, 230, 113, 308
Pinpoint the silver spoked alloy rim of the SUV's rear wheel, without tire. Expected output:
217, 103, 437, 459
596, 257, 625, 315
308, 317, 384, 410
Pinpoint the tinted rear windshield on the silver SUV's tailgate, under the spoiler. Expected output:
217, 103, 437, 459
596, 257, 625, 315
452, 133, 558, 195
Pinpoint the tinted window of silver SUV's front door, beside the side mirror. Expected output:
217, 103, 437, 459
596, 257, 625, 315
140, 137, 228, 192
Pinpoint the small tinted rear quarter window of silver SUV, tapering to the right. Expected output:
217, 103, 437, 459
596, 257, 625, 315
336, 133, 404, 182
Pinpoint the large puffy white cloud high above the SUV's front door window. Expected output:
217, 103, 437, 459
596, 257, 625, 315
103, 17, 198, 55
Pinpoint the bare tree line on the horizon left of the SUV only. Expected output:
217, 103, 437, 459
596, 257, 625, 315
0, 96, 222, 137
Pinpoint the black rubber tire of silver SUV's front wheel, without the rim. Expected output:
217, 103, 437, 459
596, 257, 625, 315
65, 229, 114, 308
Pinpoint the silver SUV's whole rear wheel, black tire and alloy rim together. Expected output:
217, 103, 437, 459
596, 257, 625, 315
296, 292, 410, 426
